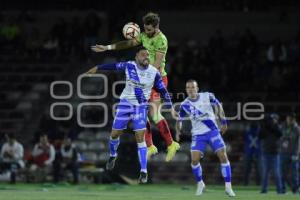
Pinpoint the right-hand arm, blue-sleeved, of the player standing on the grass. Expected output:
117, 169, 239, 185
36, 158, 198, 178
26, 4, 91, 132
209, 93, 228, 134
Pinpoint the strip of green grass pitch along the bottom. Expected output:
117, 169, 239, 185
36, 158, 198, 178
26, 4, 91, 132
0, 183, 300, 200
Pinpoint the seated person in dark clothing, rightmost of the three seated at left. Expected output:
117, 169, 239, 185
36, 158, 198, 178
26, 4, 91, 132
54, 137, 79, 184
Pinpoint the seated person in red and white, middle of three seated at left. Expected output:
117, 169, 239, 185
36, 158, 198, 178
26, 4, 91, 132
30, 134, 55, 181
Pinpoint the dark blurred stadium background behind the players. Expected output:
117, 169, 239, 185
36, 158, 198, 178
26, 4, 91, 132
0, 0, 300, 191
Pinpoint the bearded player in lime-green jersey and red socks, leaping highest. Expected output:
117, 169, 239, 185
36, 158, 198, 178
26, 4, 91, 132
92, 12, 180, 161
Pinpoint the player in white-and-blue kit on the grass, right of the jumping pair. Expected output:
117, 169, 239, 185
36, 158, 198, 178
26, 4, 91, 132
176, 80, 235, 197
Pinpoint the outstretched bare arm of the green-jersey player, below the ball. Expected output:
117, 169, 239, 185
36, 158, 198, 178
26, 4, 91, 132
91, 39, 141, 52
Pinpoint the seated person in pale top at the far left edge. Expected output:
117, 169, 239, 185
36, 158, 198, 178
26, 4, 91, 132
0, 134, 24, 183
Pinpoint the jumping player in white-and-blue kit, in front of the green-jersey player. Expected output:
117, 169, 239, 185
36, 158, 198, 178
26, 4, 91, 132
87, 47, 174, 183
